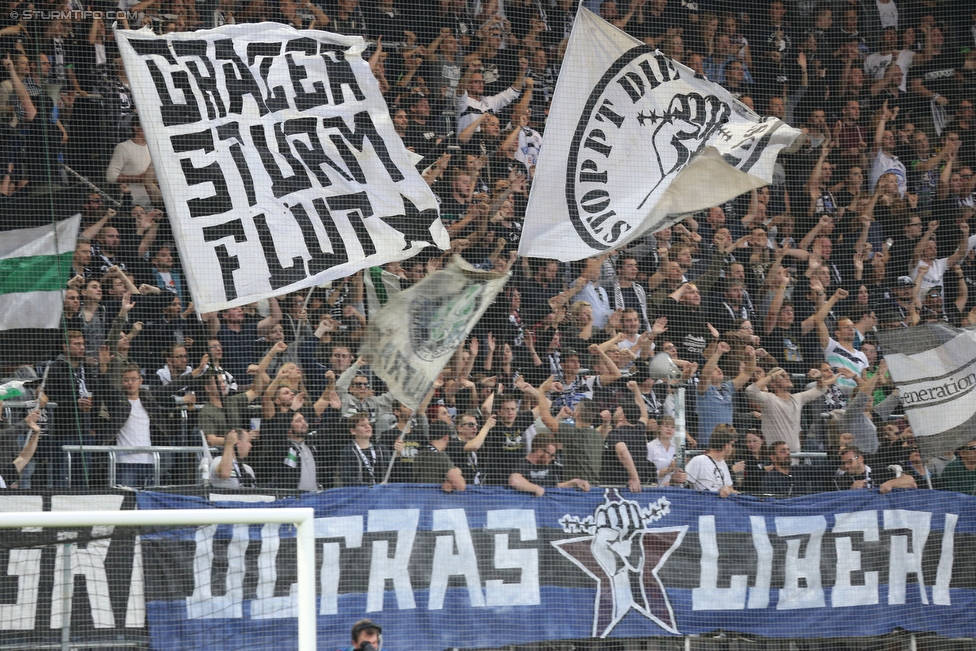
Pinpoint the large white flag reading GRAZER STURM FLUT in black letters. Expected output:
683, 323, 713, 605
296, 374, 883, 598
116, 23, 449, 312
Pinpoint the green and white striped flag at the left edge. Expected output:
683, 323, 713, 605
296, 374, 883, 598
0, 195, 81, 330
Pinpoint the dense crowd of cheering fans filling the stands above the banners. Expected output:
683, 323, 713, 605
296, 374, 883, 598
0, 0, 976, 496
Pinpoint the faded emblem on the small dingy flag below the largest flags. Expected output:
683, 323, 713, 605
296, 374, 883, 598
408, 283, 484, 362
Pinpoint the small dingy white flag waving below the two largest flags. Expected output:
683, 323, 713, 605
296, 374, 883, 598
360, 256, 511, 409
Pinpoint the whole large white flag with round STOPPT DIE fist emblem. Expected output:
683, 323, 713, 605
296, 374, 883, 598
519, 8, 802, 261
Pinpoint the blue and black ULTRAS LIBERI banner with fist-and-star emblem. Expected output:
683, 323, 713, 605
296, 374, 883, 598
138, 486, 976, 651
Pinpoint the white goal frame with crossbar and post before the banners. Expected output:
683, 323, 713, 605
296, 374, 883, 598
0, 508, 316, 651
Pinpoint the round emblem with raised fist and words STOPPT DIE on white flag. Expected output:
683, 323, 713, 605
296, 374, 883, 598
566, 46, 731, 250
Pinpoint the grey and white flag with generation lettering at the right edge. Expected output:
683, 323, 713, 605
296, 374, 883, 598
881, 323, 976, 459
